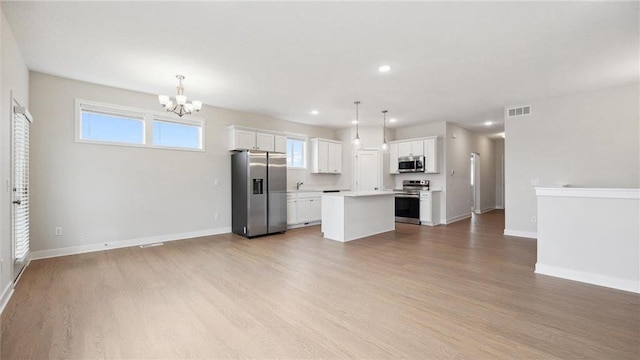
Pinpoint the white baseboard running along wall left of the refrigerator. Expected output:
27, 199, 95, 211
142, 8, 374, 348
31, 227, 231, 260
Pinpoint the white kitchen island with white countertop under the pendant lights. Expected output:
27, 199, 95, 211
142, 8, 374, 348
321, 191, 395, 242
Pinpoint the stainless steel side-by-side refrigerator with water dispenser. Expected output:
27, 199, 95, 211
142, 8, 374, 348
231, 151, 287, 237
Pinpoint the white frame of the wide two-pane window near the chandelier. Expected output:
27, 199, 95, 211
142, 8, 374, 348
74, 98, 206, 152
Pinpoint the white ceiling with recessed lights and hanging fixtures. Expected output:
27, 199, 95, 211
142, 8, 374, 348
2, 1, 640, 135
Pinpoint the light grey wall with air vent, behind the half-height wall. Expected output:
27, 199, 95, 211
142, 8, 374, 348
505, 83, 640, 237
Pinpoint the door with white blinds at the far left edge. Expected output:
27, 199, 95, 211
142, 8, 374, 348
11, 104, 31, 280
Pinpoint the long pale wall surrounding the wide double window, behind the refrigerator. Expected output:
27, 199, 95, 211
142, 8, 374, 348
30, 72, 340, 256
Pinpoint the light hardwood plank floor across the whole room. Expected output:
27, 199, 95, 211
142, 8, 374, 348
1, 211, 640, 360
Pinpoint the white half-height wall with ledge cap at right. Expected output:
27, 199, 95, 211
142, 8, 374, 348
536, 187, 640, 293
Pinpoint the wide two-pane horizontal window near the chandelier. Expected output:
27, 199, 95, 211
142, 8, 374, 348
76, 99, 204, 150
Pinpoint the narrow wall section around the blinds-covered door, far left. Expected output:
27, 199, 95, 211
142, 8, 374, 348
0, 7, 29, 310
